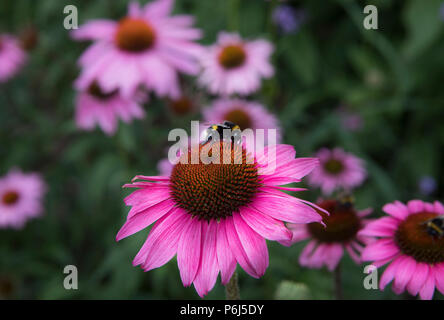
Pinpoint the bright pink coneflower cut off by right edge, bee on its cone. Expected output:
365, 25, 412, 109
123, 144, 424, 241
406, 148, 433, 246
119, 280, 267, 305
360, 200, 444, 300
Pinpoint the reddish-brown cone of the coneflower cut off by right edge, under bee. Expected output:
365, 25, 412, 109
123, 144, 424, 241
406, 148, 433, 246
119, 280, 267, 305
395, 212, 444, 263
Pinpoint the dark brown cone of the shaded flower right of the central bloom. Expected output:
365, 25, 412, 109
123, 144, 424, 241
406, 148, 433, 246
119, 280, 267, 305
307, 200, 361, 243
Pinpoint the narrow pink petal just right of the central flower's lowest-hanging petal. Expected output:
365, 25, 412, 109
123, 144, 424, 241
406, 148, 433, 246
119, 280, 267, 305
216, 219, 236, 284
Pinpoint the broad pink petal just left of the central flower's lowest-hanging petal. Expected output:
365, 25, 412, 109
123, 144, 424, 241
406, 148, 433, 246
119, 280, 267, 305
177, 216, 202, 287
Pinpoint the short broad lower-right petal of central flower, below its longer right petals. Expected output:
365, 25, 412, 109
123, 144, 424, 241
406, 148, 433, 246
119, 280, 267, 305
240, 207, 292, 241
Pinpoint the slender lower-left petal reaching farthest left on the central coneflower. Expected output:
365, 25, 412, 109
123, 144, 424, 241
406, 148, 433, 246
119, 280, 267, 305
116, 200, 174, 241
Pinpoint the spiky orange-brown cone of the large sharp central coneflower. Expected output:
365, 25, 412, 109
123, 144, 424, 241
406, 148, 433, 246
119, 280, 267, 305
171, 142, 261, 221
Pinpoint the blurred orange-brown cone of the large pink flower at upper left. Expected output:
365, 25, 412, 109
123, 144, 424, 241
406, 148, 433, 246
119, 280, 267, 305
115, 18, 156, 53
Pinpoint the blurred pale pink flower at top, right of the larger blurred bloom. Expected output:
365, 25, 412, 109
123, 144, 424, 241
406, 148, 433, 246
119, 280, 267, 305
199, 32, 274, 95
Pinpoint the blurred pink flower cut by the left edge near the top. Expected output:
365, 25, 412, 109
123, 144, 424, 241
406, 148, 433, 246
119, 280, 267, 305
0, 34, 27, 83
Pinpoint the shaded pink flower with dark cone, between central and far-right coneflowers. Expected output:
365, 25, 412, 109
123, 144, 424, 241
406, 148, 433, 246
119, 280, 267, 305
287, 199, 372, 271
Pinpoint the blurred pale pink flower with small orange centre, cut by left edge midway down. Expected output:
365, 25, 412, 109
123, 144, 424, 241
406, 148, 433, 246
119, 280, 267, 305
0, 169, 46, 229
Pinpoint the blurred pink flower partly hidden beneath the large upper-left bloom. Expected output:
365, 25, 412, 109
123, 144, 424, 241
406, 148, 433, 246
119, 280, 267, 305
75, 82, 145, 135
